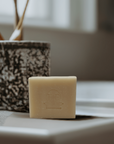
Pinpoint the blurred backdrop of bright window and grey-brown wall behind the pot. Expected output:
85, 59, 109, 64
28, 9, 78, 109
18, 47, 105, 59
0, 0, 114, 81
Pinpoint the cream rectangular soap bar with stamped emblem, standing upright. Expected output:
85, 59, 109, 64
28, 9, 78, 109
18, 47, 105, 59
29, 76, 77, 119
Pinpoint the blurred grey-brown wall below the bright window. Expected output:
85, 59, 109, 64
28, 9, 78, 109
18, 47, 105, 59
0, 25, 114, 80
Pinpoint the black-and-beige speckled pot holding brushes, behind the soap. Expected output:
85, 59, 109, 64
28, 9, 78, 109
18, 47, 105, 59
0, 41, 50, 112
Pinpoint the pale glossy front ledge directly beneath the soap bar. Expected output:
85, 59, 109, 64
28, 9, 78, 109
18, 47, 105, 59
0, 112, 114, 144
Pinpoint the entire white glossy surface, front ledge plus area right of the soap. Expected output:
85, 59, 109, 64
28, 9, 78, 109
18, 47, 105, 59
0, 82, 114, 144
